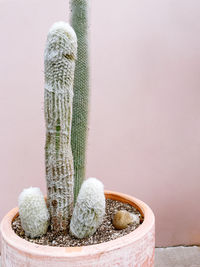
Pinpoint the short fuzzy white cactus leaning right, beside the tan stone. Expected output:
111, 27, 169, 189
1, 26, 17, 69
70, 178, 105, 238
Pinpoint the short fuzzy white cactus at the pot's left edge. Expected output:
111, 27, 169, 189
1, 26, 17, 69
18, 187, 49, 238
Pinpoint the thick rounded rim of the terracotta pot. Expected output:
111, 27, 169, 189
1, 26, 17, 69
0, 191, 155, 259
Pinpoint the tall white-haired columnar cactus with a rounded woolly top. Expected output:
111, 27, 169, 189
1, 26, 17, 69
44, 22, 77, 231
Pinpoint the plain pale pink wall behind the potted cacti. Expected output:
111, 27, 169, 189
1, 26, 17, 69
0, 0, 200, 246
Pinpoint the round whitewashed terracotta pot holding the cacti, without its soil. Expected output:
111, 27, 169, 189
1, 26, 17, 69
1, 191, 155, 267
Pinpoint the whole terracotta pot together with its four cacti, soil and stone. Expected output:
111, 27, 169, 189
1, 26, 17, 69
1, 0, 155, 267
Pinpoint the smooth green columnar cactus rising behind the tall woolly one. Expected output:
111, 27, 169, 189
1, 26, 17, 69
70, 0, 89, 201
